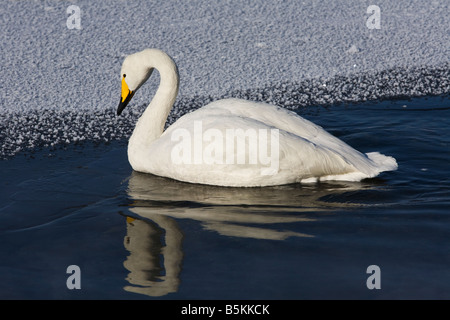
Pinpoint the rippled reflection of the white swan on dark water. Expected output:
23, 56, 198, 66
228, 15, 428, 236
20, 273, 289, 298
124, 172, 374, 296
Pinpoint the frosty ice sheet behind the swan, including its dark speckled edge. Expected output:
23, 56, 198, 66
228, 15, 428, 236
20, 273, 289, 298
0, 0, 450, 158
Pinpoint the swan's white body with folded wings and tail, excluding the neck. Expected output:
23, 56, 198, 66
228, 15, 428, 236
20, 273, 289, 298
143, 99, 396, 186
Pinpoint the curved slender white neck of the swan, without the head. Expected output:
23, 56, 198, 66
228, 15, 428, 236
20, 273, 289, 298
128, 49, 179, 167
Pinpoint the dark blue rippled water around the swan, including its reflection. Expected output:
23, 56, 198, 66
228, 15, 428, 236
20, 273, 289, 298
0, 96, 450, 299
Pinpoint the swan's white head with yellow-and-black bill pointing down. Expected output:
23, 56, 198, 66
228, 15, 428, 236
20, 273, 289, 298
117, 52, 153, 115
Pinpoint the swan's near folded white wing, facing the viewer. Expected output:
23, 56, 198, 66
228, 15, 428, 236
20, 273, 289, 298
148, 112, 366, 186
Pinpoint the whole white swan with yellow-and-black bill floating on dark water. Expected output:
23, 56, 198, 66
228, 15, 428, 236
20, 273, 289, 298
117, 49, 397, 187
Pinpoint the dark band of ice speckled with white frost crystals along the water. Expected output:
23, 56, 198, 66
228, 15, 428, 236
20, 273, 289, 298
0, 64, 450, 159
